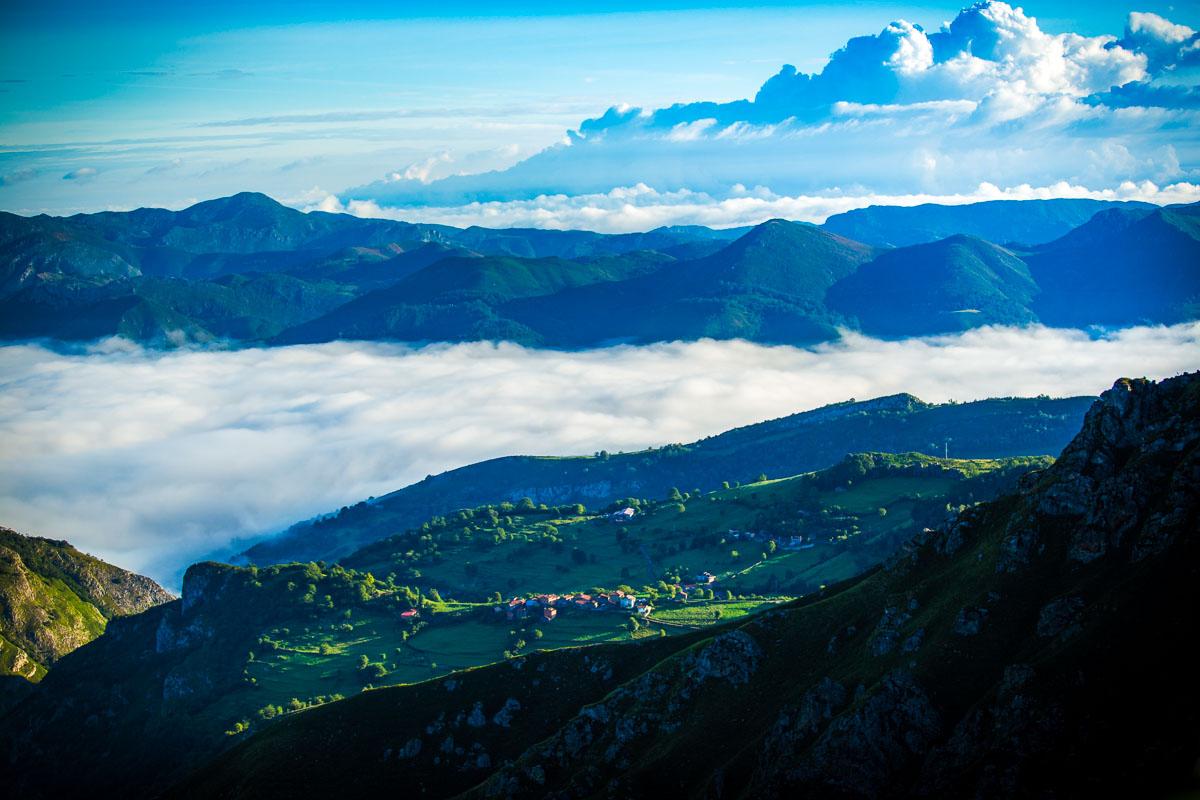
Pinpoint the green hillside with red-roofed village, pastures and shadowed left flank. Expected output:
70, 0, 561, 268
0, 453, 1050, 796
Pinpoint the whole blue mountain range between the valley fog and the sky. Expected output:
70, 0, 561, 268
0, 193, 1200, 348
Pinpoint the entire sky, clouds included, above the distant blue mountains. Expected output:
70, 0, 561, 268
0, 0, 1200, 225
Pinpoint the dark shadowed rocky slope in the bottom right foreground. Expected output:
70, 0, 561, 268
172, 374, 1200, 799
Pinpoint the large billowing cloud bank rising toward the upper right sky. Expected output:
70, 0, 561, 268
340, 1, 1200, 207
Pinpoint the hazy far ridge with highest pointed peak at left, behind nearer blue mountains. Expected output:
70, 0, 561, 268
0, 192, 738, 291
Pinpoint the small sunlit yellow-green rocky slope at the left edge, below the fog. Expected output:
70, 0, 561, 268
0, 528, 173, 681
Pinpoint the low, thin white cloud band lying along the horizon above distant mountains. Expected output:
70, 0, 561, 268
302, 179, 1200, 233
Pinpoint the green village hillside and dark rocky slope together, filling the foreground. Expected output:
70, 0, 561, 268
0, 374, 1200, 798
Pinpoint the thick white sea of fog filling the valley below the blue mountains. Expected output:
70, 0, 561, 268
0, 323, 1200, 585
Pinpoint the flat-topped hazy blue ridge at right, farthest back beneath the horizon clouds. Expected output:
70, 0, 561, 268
822, 199, 1156, 247
